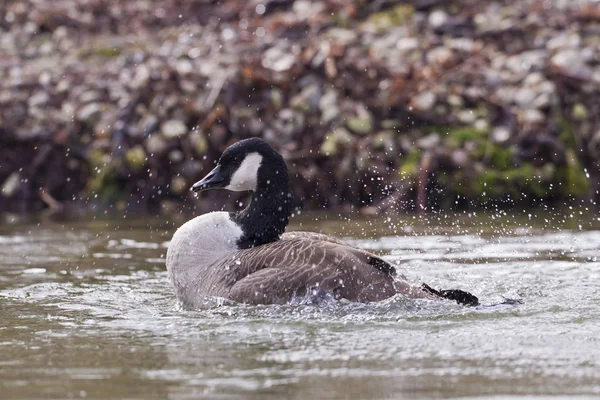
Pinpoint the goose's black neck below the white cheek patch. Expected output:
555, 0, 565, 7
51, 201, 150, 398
231, 164, 292, 249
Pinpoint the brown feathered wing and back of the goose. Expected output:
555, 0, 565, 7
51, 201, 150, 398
223, 235, 396, 304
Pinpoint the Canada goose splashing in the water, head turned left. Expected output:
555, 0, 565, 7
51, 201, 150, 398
167, 138, 478, 308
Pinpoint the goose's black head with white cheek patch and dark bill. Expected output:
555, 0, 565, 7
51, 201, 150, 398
191, 138, 288, 192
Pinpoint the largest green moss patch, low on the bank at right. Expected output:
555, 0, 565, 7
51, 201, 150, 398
399, 122, 590, 208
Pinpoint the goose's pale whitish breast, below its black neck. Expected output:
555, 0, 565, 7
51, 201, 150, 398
167, 212, 243, 302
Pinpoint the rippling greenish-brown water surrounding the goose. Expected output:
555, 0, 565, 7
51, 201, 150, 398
0, 210, 600, 399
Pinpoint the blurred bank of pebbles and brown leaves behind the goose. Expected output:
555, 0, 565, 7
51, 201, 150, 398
0, 0, 600, 214
